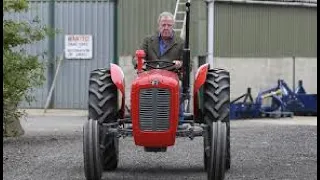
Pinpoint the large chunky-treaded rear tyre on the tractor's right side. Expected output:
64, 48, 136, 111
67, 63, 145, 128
203, 69, 231, 177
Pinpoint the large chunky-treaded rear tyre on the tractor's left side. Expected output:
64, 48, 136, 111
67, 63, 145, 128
88, 69, 119, 171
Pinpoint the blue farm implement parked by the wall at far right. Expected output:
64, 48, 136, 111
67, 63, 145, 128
230, 80, 317, 119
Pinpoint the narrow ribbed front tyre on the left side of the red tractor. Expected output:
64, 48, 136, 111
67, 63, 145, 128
83, 119, 102, 180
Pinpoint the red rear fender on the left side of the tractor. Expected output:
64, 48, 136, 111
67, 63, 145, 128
110, 63, 125, 118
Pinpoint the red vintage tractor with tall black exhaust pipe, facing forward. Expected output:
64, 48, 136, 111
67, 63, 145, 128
83, 3, 230, 180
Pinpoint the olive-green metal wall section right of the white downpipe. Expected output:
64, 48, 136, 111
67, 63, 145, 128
215, 3, 317, 57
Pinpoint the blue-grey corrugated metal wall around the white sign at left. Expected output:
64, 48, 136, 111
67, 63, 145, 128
6, 0, 115, 109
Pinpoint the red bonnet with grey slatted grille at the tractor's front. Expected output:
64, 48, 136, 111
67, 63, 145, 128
131, 69, 180, 149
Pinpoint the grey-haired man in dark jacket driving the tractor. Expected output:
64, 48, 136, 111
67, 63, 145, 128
133, 12, 185, 129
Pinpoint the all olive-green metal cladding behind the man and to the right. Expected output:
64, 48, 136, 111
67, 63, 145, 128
117, 0, 317, 57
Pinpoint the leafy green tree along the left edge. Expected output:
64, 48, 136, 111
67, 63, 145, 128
3, 0, 53, 137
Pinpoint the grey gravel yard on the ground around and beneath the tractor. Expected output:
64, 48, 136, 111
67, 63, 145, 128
3, 116, 317, 180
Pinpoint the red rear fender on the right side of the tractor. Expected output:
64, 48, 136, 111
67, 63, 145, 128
193, 63, 209, 119
